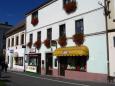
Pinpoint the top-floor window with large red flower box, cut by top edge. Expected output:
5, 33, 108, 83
63, 0, 77, 13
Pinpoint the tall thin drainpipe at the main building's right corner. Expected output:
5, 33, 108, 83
104, 0, 110, 82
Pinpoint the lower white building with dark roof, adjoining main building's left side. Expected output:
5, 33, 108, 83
6, 22, 25, 71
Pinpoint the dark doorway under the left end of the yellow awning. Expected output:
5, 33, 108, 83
59, 57, 67, 76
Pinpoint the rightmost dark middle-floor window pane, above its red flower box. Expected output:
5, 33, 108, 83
75, 19, 84, 34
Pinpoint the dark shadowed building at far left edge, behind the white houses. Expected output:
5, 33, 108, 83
0, 22, 13, 56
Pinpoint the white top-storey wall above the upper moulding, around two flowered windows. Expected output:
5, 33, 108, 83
27, 0, 103, 32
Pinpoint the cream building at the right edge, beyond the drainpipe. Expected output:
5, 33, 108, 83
107, 0, 115, 77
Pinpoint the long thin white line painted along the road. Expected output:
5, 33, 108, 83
11, 72, 90, 86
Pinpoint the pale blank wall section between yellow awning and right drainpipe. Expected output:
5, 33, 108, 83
85, 34, 107, 74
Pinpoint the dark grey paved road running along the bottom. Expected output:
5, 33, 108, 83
3, 72, 115, 86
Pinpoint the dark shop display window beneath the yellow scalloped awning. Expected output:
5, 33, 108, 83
60, 56, 87, 72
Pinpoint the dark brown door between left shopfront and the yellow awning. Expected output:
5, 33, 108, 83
46, 53, 53, 75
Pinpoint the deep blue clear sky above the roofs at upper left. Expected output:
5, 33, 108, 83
0, 0, 47, 26
